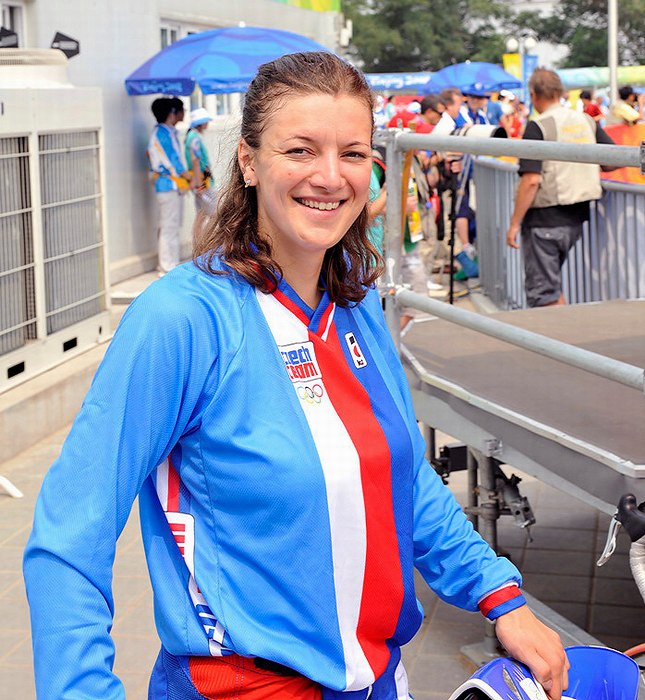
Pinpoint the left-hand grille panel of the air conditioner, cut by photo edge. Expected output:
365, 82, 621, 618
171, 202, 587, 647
0, 136, 36, 355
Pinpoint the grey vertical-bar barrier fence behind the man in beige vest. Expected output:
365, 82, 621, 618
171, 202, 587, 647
474, 158, 645, 309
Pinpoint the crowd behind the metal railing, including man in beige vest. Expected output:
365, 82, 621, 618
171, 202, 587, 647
375, 74, 645, 308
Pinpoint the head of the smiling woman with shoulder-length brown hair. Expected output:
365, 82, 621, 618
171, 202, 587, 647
195, 53, 381, 308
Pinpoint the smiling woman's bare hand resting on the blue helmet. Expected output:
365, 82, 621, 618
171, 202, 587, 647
495, 605, 569, 700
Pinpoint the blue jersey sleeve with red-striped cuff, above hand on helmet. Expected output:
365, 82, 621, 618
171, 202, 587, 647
360, 295, 524, 617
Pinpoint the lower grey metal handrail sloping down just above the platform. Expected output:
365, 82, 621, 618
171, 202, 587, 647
394, 286, 645, 393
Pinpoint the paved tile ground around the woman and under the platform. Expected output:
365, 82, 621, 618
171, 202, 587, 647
0, 272, 645, 700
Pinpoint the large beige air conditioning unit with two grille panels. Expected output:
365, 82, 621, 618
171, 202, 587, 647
0, 49, 109, 392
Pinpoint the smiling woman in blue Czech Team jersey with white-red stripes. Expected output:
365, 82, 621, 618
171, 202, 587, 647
24, 52, 566, 700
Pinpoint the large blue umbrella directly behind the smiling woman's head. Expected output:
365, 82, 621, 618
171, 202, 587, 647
125, 27, 329, 95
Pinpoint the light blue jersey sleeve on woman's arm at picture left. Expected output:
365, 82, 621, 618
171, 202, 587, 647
23, 280, 215, 700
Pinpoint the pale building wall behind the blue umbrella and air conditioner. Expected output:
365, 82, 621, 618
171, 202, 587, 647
18, 0, 337, 282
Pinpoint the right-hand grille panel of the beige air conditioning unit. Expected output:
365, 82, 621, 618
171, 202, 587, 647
38, 131, 105, 334
